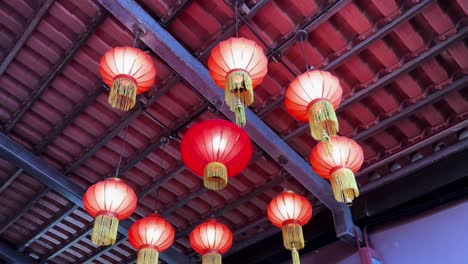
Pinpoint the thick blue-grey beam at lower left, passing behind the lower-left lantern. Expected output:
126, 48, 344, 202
0, 133, 191, 264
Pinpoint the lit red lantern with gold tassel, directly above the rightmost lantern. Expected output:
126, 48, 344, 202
285, 70, 343, 152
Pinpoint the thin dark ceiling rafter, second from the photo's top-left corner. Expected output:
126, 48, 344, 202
3, 10, 109, 134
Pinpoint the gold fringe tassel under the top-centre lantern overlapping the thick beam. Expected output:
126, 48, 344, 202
224, 70, 254, 127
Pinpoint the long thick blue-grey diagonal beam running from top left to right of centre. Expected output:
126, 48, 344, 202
95, 0, 355, 244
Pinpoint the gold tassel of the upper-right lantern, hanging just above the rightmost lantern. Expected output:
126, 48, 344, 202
308, 99, 339, 147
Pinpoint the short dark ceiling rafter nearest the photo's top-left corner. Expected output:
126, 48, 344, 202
0, 0, 55, 75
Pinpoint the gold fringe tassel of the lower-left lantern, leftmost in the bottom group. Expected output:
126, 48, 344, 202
91, 215, 119, 246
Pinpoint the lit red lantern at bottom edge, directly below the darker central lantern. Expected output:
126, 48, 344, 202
190, 219, 233, 264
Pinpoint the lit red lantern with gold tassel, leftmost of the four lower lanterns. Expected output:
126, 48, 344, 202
83, 178, 137, 246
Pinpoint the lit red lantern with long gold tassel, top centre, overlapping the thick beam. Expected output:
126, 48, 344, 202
208, 38, 268, 126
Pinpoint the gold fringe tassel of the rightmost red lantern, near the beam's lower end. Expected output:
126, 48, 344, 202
330, 168, 359, 206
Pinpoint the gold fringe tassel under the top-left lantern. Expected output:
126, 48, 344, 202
108, 77, 137, 111
